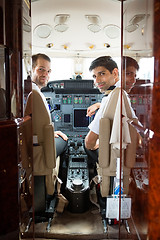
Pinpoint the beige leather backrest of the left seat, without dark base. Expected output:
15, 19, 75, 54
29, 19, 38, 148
25, 89, 59, 194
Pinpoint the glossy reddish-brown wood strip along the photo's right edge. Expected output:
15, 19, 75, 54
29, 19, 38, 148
148, 0, 160, 240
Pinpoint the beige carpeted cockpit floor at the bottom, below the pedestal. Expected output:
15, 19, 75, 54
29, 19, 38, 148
23, 204, 134, 240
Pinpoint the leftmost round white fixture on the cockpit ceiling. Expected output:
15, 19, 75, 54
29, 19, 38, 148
34, 24, 52, 38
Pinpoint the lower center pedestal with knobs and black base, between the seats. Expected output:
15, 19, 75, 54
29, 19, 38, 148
66, 154, 89, 213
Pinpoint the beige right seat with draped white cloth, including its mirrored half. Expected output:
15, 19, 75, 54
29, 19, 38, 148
97, 88, 138, 197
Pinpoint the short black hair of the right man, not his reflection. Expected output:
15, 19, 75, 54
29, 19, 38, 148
89, 56, 118, 73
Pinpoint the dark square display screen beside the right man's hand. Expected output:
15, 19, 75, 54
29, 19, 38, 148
74, 109, 89, 128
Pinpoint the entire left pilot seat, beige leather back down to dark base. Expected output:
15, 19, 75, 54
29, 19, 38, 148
25, 90, 60, 230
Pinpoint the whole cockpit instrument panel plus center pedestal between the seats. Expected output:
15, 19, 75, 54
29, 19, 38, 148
42, 80, 102, 213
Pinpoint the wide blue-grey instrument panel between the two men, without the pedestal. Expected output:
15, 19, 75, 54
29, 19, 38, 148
43, 80, 102, 136
